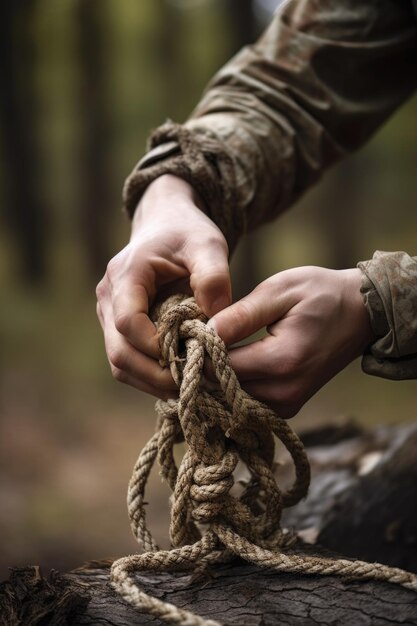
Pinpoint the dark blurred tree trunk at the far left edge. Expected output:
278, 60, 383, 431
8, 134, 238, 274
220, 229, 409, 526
0, 0, 48, 285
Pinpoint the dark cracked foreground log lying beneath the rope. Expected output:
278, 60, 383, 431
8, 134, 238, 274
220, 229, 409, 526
0, 562, 417, 626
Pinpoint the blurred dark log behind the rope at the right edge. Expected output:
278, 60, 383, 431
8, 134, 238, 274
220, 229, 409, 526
283, 424, 417, 572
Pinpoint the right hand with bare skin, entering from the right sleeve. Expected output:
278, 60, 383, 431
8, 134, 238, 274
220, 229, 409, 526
209, 267, 373, 418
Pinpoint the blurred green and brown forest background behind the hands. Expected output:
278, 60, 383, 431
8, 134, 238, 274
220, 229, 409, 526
0, 0, 417, 578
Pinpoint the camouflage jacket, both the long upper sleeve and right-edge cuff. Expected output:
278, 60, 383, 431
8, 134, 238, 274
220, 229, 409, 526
124, 0, 417, 379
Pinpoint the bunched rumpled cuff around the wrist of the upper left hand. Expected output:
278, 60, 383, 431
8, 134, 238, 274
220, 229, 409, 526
123, 122, 245, 250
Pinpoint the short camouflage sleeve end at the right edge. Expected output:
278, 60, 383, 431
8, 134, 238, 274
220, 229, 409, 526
358, 251, 417, 380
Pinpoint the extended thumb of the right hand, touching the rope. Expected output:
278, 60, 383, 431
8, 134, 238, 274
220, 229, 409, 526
209, 281, 294, 346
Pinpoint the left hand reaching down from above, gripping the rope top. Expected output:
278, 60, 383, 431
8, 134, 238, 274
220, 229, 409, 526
97, 175, 231, 399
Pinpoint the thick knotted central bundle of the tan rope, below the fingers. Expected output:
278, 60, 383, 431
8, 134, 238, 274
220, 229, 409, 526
155, 296, 309, 547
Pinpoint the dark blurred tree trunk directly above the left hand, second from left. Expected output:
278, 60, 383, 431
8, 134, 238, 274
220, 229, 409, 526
76, 0, 113, 283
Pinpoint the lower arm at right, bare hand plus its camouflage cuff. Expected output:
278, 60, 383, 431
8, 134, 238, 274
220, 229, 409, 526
209, 252, 417, 418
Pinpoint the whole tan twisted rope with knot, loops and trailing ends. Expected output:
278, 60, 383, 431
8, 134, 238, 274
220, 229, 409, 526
111, 296, 417, 626
